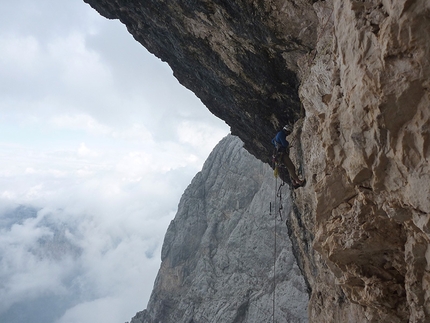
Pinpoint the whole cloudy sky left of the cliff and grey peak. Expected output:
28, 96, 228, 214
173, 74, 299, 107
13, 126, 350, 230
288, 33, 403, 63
0, 0, 229, 323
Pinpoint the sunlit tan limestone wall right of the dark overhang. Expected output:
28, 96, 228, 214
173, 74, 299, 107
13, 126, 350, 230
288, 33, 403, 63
296, 1, 430, 322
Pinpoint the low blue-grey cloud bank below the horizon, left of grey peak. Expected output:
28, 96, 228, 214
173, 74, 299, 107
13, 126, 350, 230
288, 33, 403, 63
0, 207, 166, 323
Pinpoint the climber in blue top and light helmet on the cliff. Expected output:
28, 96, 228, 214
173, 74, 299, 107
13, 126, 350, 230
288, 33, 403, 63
272, 125, 305, 188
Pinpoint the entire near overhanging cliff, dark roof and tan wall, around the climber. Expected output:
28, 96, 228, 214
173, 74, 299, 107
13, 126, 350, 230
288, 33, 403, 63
85, 0, 430, 322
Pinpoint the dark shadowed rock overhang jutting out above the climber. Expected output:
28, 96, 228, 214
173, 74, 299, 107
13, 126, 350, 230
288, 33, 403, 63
85, 0, 317, 161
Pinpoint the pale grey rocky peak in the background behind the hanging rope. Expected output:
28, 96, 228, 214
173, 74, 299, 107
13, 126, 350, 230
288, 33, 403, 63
131, 136, 309, 323
